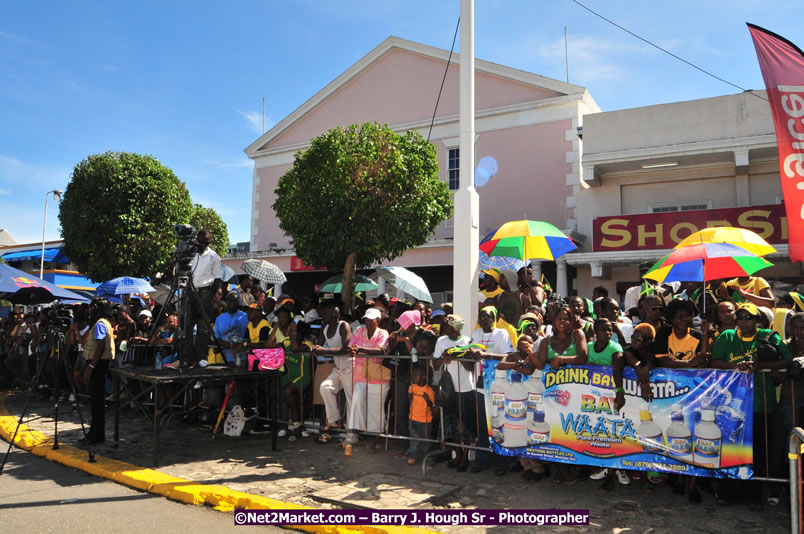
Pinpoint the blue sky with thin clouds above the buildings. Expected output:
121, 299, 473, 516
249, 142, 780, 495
0, 0, 804, 246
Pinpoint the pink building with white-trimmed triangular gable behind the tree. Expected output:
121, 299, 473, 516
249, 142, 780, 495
242, 37, 599, 301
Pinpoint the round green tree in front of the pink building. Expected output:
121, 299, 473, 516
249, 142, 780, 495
273, 123, 452, 309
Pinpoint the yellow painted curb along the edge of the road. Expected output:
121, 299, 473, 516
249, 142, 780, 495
0, 393, 438, 534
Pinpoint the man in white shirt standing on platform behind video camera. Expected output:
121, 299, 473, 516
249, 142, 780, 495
184, 228, 223, 362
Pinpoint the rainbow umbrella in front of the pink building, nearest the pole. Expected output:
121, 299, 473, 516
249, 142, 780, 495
480, 221, 578, 261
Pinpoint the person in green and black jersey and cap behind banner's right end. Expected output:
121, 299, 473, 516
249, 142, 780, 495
712, 303, 793, 510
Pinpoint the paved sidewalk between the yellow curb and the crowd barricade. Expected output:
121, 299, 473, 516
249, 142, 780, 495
0, 394, 790, 533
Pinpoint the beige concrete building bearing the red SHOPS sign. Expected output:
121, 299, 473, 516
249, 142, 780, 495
567, 91, 801, 297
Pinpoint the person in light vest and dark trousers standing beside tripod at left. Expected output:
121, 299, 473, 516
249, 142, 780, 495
81, 299, 115, 445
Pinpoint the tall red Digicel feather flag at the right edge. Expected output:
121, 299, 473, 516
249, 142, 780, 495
748, 24, 804, 261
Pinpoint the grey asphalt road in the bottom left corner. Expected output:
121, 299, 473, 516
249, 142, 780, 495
0, 450, 283, 534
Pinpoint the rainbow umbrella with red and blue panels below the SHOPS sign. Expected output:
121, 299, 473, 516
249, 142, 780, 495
643, 243, 773, 284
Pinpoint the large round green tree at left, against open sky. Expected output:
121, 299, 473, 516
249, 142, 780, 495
59, 152, 193, 282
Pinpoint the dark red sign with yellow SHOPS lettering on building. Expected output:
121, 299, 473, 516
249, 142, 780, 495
592, 204, 787, 252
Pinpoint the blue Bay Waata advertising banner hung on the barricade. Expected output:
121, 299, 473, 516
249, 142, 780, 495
483, 360, 754, 479
